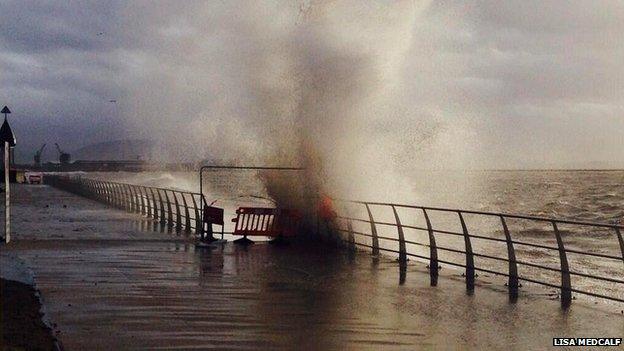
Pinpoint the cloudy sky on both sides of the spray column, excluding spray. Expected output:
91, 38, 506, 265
0, 0, 624, 168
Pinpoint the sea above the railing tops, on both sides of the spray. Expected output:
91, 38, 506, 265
90, 170, 624, 224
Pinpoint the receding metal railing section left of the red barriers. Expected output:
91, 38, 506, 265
44, 175, 214, 238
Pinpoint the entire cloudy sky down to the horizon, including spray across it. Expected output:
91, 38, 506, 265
0, 0, 624, 172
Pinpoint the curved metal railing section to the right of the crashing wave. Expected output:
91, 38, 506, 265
334, 200, 624, 308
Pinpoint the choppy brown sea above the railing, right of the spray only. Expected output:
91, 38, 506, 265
415, 171, 624, 223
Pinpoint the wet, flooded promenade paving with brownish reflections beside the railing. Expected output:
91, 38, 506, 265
2, 185, 624, 350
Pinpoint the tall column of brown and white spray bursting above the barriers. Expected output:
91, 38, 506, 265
251, 2, 432, 236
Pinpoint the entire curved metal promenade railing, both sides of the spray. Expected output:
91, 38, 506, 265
45, 175, 624, 308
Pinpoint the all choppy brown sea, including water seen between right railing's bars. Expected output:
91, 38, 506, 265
90, 171, 624, 306
